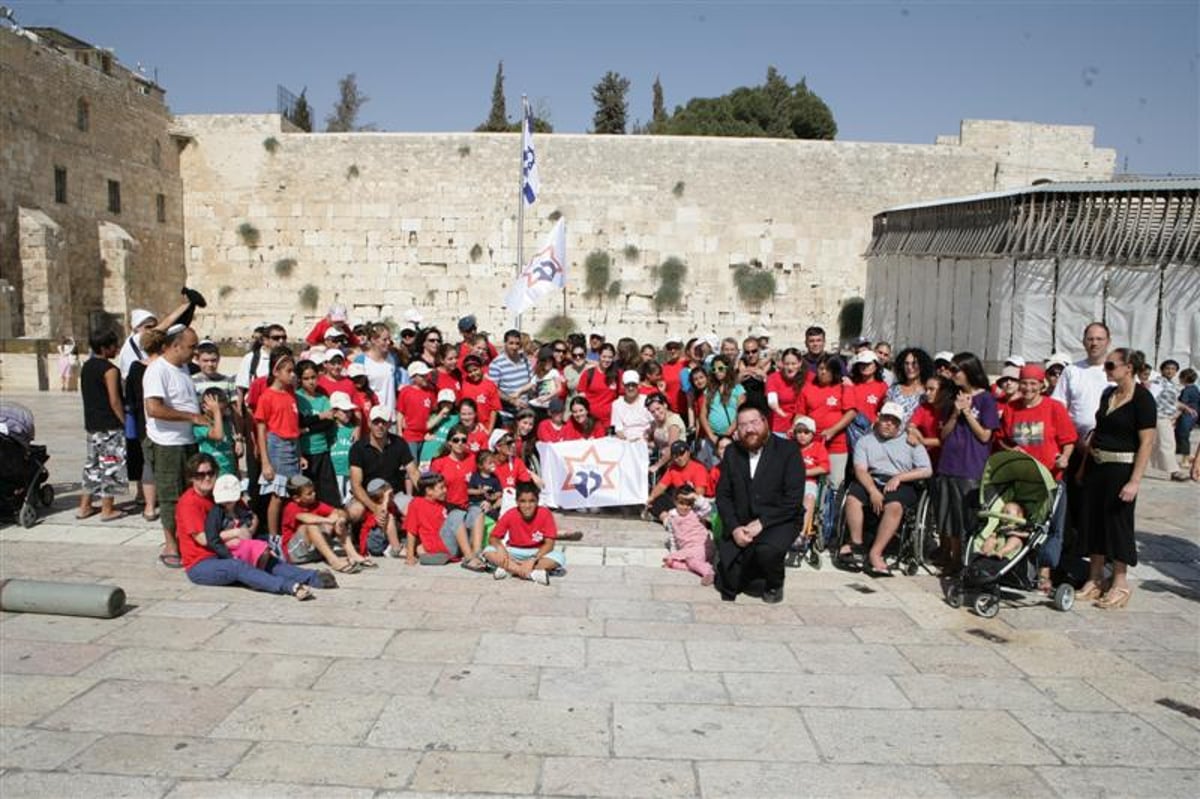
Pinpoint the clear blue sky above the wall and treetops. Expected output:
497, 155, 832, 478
11, 0, 1200, 174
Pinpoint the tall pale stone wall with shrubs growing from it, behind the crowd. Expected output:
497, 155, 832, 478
176, 115, 1115, 340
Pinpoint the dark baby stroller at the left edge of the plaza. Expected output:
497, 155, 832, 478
0, 402, 54, 528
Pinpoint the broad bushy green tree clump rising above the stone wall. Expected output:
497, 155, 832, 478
650, 66, 838, 139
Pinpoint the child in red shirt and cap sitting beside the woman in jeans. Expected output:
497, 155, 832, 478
280, 474, 376, 575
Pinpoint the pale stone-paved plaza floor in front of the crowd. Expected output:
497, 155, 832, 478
0, 394, 1200, 799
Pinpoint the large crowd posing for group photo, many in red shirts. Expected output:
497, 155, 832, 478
78, 289, 1200, 607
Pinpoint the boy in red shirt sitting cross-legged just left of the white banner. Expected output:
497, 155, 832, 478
484, 482, 566, 585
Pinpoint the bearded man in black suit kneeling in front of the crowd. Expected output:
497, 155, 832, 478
716, 402, 804, 605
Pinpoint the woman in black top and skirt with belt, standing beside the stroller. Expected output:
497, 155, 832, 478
1076, 347, 1157, 609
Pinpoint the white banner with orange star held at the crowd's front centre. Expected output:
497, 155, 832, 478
538, 438, 650, 509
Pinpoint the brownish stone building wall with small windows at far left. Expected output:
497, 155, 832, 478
0, 28, 185, 340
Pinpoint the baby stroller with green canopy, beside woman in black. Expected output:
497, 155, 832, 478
946, 451, 1075, 619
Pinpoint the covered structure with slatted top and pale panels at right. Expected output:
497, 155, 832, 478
864, 179, 1200, 365
